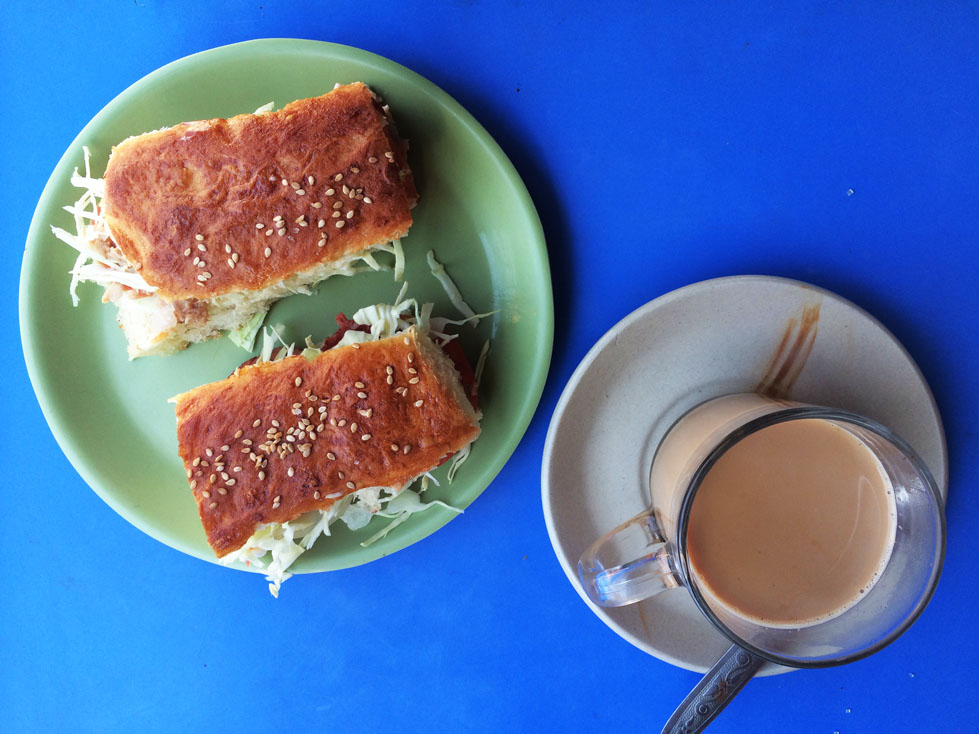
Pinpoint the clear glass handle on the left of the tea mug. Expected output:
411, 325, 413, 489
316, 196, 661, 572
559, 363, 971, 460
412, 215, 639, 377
578, 510, 682, 607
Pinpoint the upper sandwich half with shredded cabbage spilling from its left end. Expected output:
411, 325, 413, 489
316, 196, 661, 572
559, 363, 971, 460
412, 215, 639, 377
53, 83, 417, 358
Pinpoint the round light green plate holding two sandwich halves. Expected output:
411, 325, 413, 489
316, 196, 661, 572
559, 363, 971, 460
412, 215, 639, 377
20, 39, 554, 572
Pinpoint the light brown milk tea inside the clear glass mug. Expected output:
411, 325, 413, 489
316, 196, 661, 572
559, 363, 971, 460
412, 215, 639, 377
651, 395, 897, 627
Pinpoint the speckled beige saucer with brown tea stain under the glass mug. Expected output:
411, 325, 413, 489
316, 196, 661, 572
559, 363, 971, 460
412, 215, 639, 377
541, 276, 948, 674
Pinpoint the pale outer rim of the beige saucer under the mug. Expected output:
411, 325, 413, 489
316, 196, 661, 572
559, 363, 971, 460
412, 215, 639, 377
540, 274, 949, 676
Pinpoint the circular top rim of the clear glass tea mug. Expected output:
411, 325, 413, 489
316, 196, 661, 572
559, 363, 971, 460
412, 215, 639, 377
675, 405, 946, 668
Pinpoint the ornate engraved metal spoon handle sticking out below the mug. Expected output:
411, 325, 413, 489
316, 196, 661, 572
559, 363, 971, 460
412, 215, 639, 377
663, 645, 765, 734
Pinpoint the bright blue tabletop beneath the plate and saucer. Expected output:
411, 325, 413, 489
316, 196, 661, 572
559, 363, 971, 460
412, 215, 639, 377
0, 0, 979, 734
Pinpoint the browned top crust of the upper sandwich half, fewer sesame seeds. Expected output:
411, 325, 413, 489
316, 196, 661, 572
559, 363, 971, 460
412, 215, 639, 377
103, 82, 417, 300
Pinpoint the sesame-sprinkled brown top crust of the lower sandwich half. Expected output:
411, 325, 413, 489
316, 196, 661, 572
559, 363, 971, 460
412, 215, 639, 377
176, 328, 479, 557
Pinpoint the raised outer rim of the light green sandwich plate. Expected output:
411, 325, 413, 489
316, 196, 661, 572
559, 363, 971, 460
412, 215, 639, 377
23, 37, 554, 574
